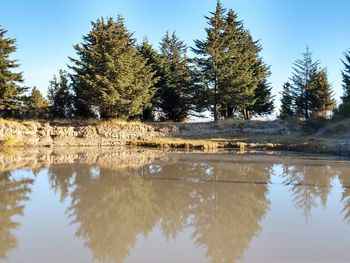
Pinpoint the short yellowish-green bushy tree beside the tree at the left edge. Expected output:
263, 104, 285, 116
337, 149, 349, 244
26, 87, 49, 118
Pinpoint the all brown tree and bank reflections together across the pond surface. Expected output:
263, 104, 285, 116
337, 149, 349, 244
0, 148, 350, 262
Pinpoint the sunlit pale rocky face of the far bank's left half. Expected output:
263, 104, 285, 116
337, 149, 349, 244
0, 121, 178, 147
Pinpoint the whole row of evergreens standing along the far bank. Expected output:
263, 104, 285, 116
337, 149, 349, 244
0, 1, 350, 121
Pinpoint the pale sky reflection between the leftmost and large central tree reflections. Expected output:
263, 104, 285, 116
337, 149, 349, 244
9, 169, 91, 263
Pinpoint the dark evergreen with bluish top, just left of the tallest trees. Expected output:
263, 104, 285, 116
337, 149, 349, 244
159, 32, 194, 121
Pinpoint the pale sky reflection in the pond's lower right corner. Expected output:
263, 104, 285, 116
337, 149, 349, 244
243, 173, 350, 263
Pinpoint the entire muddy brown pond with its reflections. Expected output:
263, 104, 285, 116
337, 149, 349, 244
0, 149, 350, 263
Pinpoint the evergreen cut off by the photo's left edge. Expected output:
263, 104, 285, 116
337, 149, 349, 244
0, 27, 27, 118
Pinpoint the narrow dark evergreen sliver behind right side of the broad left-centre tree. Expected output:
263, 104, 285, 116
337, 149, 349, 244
139, 39, 164, 121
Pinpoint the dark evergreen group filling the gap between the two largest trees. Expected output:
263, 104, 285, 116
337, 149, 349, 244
139, 33, 207, 121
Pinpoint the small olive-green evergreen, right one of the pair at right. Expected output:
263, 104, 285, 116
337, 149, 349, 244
311, 69, 336, 118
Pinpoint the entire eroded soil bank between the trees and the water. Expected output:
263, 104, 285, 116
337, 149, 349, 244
0, 119, 350, 156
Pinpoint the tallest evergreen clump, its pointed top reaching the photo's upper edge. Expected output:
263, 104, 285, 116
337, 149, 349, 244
193, 1, 273, 120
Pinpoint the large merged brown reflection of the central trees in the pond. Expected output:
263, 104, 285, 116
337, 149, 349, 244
50, 158, 272, 262
